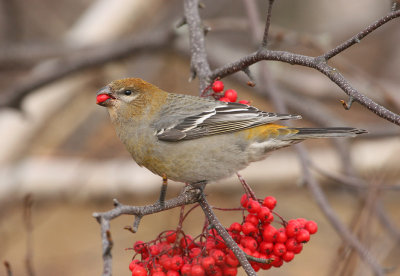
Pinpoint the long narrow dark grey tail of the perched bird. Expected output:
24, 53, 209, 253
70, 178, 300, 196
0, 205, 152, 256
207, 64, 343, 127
291, 127, 368, 140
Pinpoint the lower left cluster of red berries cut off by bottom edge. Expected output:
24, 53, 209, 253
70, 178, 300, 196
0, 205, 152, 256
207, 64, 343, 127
129, 230, 239, 276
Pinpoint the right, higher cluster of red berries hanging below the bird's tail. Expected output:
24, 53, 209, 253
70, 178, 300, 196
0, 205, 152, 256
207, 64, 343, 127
236, 194, 318, 271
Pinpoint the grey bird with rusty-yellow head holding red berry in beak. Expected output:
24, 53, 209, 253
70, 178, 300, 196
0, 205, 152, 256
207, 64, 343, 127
97, 78, 366, 184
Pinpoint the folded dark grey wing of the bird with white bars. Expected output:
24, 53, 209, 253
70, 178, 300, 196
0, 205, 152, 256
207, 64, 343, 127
156, 101, 301, 142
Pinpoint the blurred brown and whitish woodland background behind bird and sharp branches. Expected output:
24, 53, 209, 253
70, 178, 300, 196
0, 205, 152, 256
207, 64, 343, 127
0, 0, 400, 275
